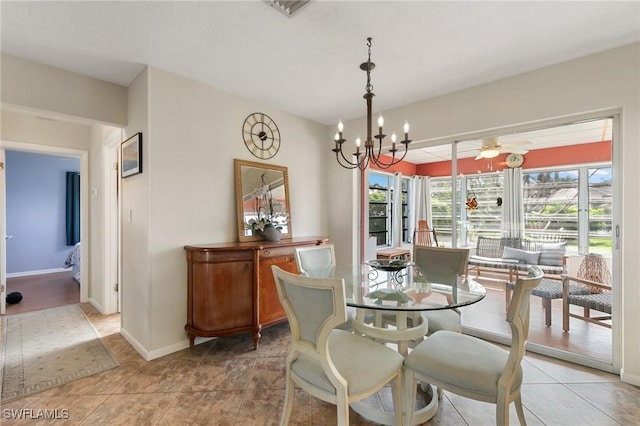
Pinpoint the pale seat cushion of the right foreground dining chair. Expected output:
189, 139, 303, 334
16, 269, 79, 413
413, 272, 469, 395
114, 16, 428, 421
404, 331, 522, 397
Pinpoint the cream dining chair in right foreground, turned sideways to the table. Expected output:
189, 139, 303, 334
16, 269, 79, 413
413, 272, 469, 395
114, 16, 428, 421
404, 266, 543, 426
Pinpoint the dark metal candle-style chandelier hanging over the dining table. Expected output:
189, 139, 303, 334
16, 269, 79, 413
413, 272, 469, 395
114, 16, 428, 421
331, 37, 411, 170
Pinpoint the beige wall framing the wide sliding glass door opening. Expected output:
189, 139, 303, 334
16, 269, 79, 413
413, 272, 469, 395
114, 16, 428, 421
325, 43, 640, 385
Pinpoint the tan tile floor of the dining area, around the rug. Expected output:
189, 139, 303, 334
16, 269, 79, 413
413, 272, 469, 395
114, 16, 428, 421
0, 304, 640, 426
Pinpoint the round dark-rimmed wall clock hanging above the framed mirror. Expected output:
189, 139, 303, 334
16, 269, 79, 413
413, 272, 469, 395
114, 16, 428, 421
242, 112, 280, 160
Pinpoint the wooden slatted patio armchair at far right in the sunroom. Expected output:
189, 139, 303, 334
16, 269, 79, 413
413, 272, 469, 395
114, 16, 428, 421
562, 254, 612, 332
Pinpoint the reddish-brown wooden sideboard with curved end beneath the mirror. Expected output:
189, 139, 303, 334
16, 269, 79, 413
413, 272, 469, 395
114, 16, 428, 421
184, 237, 327, 348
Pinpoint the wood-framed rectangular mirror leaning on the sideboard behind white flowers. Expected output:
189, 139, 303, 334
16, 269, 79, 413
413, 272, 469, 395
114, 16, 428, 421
234, 159, 293, 242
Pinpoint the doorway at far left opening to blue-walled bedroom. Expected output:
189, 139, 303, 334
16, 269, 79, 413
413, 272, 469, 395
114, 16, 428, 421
5, 150, 81, 315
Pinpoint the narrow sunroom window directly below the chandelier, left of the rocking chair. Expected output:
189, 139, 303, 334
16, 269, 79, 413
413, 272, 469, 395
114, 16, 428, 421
369, 172, 410, 246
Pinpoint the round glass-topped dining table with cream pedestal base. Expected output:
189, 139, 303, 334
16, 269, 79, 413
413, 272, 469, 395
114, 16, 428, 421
305, 261, 486, 424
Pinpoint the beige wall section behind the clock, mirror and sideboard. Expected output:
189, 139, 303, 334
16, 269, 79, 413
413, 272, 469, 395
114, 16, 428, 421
122, 68, 327, 358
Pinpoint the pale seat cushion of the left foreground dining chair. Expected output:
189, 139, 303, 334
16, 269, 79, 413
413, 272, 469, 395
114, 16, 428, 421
291, 329, 403, 395
